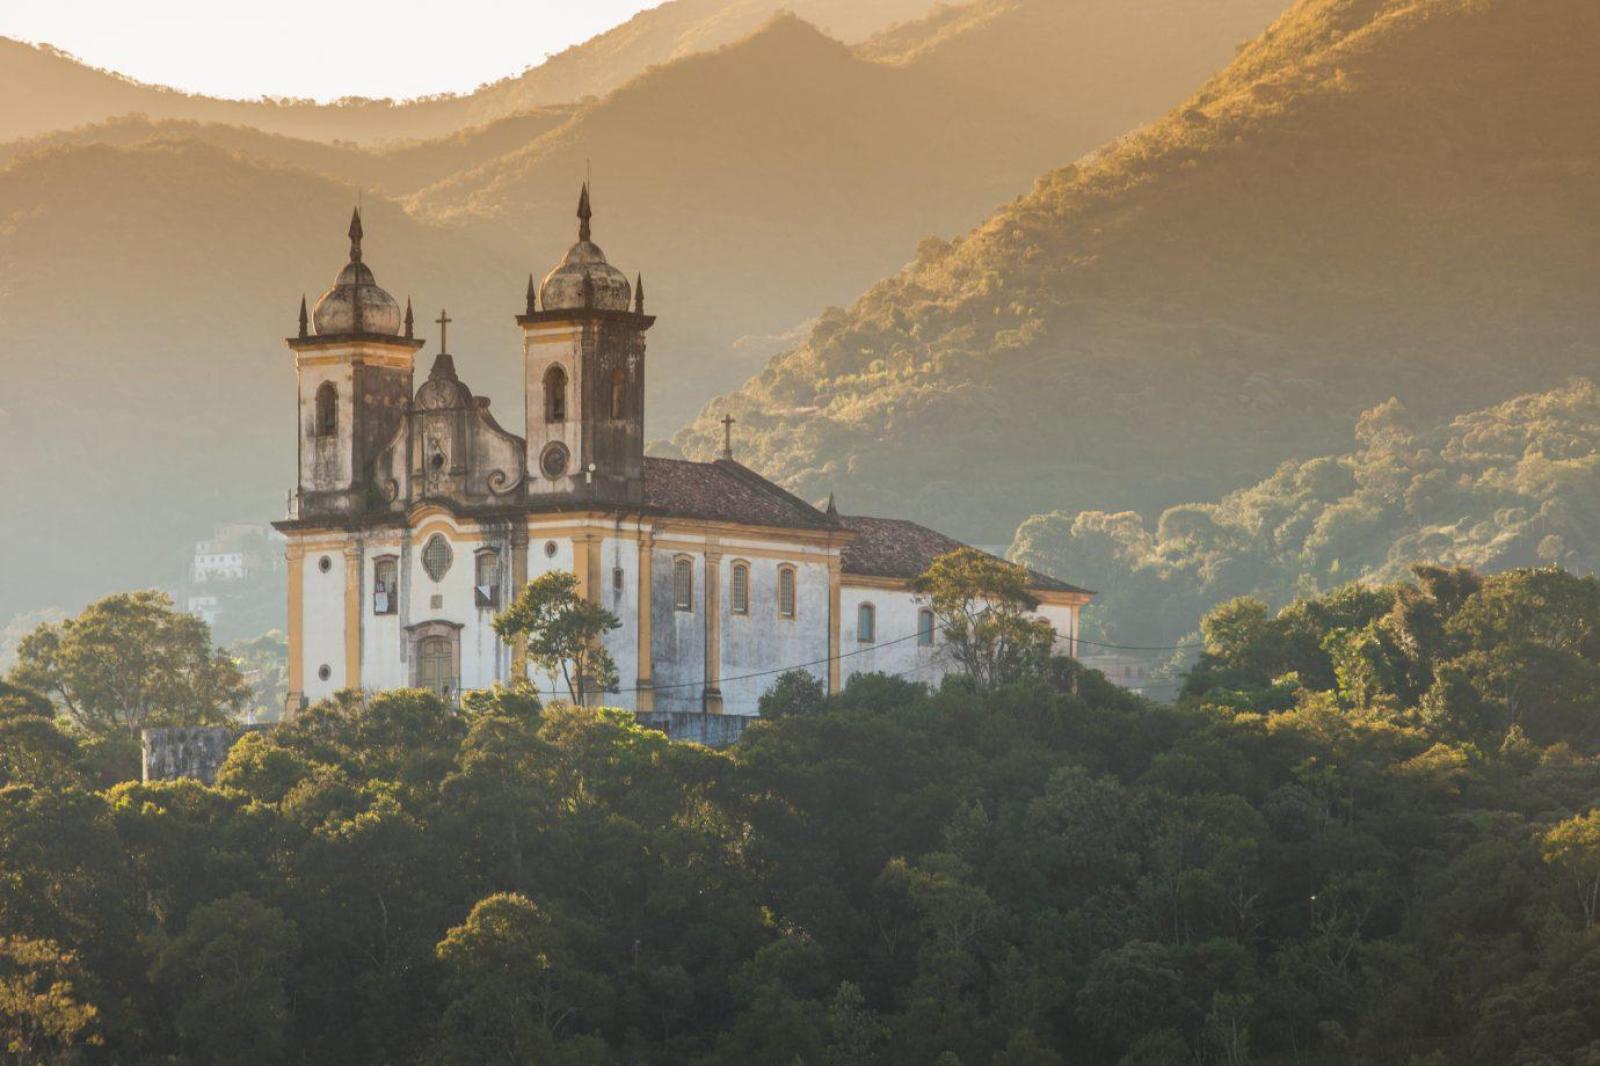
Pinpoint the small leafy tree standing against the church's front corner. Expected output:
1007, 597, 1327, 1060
494, 570, 622, 703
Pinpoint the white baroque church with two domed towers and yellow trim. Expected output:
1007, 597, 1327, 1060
274, 186, 1091, 714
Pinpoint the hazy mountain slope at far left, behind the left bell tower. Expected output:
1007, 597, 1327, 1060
0, 146, 524, 616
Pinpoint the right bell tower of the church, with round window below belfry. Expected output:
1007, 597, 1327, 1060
517, 182, 654, 503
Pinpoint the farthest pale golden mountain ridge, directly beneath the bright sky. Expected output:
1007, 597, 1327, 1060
0, 0, 928, 142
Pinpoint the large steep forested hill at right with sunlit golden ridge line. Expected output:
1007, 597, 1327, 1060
675, 0, 1600, 539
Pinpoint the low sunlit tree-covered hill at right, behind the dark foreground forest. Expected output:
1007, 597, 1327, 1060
1013, 379, 1600, 643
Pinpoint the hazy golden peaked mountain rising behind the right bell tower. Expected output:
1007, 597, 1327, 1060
413, 0, 1277, 432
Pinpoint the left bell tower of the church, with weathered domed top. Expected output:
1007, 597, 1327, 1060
288, 208, 422, 517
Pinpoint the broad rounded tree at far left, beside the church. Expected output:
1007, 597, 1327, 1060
11, 592, 248, 741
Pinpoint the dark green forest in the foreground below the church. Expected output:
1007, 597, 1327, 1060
15, 570, 1600, 1066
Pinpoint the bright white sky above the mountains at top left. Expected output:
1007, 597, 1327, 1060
0, 0, 661, 99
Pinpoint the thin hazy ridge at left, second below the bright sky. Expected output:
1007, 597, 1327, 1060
0, 106, 574, 195
